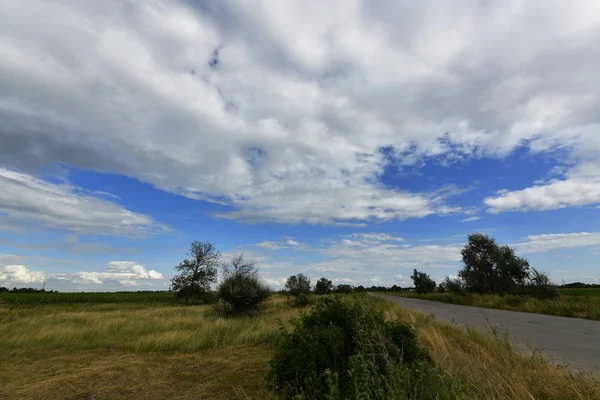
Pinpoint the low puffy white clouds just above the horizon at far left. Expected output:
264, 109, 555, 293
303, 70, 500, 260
0, 261, 164, 286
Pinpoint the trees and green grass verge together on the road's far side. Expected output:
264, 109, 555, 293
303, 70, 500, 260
390, 234, 600, 320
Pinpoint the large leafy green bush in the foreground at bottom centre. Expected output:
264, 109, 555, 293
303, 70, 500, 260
267, 297, 460, 400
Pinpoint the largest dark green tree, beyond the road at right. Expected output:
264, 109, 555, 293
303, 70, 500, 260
458, 233, 529, 294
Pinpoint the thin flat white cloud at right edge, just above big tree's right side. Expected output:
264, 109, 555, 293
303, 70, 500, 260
514, 232, 600, 253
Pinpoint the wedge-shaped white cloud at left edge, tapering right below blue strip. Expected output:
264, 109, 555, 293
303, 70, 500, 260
0, 168, 167, 237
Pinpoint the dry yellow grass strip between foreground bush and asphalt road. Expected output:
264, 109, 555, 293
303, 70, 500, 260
385, 304, 600, 400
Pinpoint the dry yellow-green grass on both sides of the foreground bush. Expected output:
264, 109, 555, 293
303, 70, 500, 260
0, 294, 600, 399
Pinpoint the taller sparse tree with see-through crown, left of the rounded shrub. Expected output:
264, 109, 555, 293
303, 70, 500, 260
171, 241, 221, 302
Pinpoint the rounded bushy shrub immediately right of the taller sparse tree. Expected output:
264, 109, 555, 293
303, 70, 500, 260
217, 254, 271, 314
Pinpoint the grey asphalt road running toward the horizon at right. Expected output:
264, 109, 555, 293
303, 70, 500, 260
373, 293, 600, 374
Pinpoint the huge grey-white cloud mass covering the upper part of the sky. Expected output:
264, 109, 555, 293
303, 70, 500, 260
0, 0, 600, 223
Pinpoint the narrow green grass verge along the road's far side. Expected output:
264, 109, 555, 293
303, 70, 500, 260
386, 289, 600, 320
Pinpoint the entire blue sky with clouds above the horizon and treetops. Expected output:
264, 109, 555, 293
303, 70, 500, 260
0, 0, 600, 291
